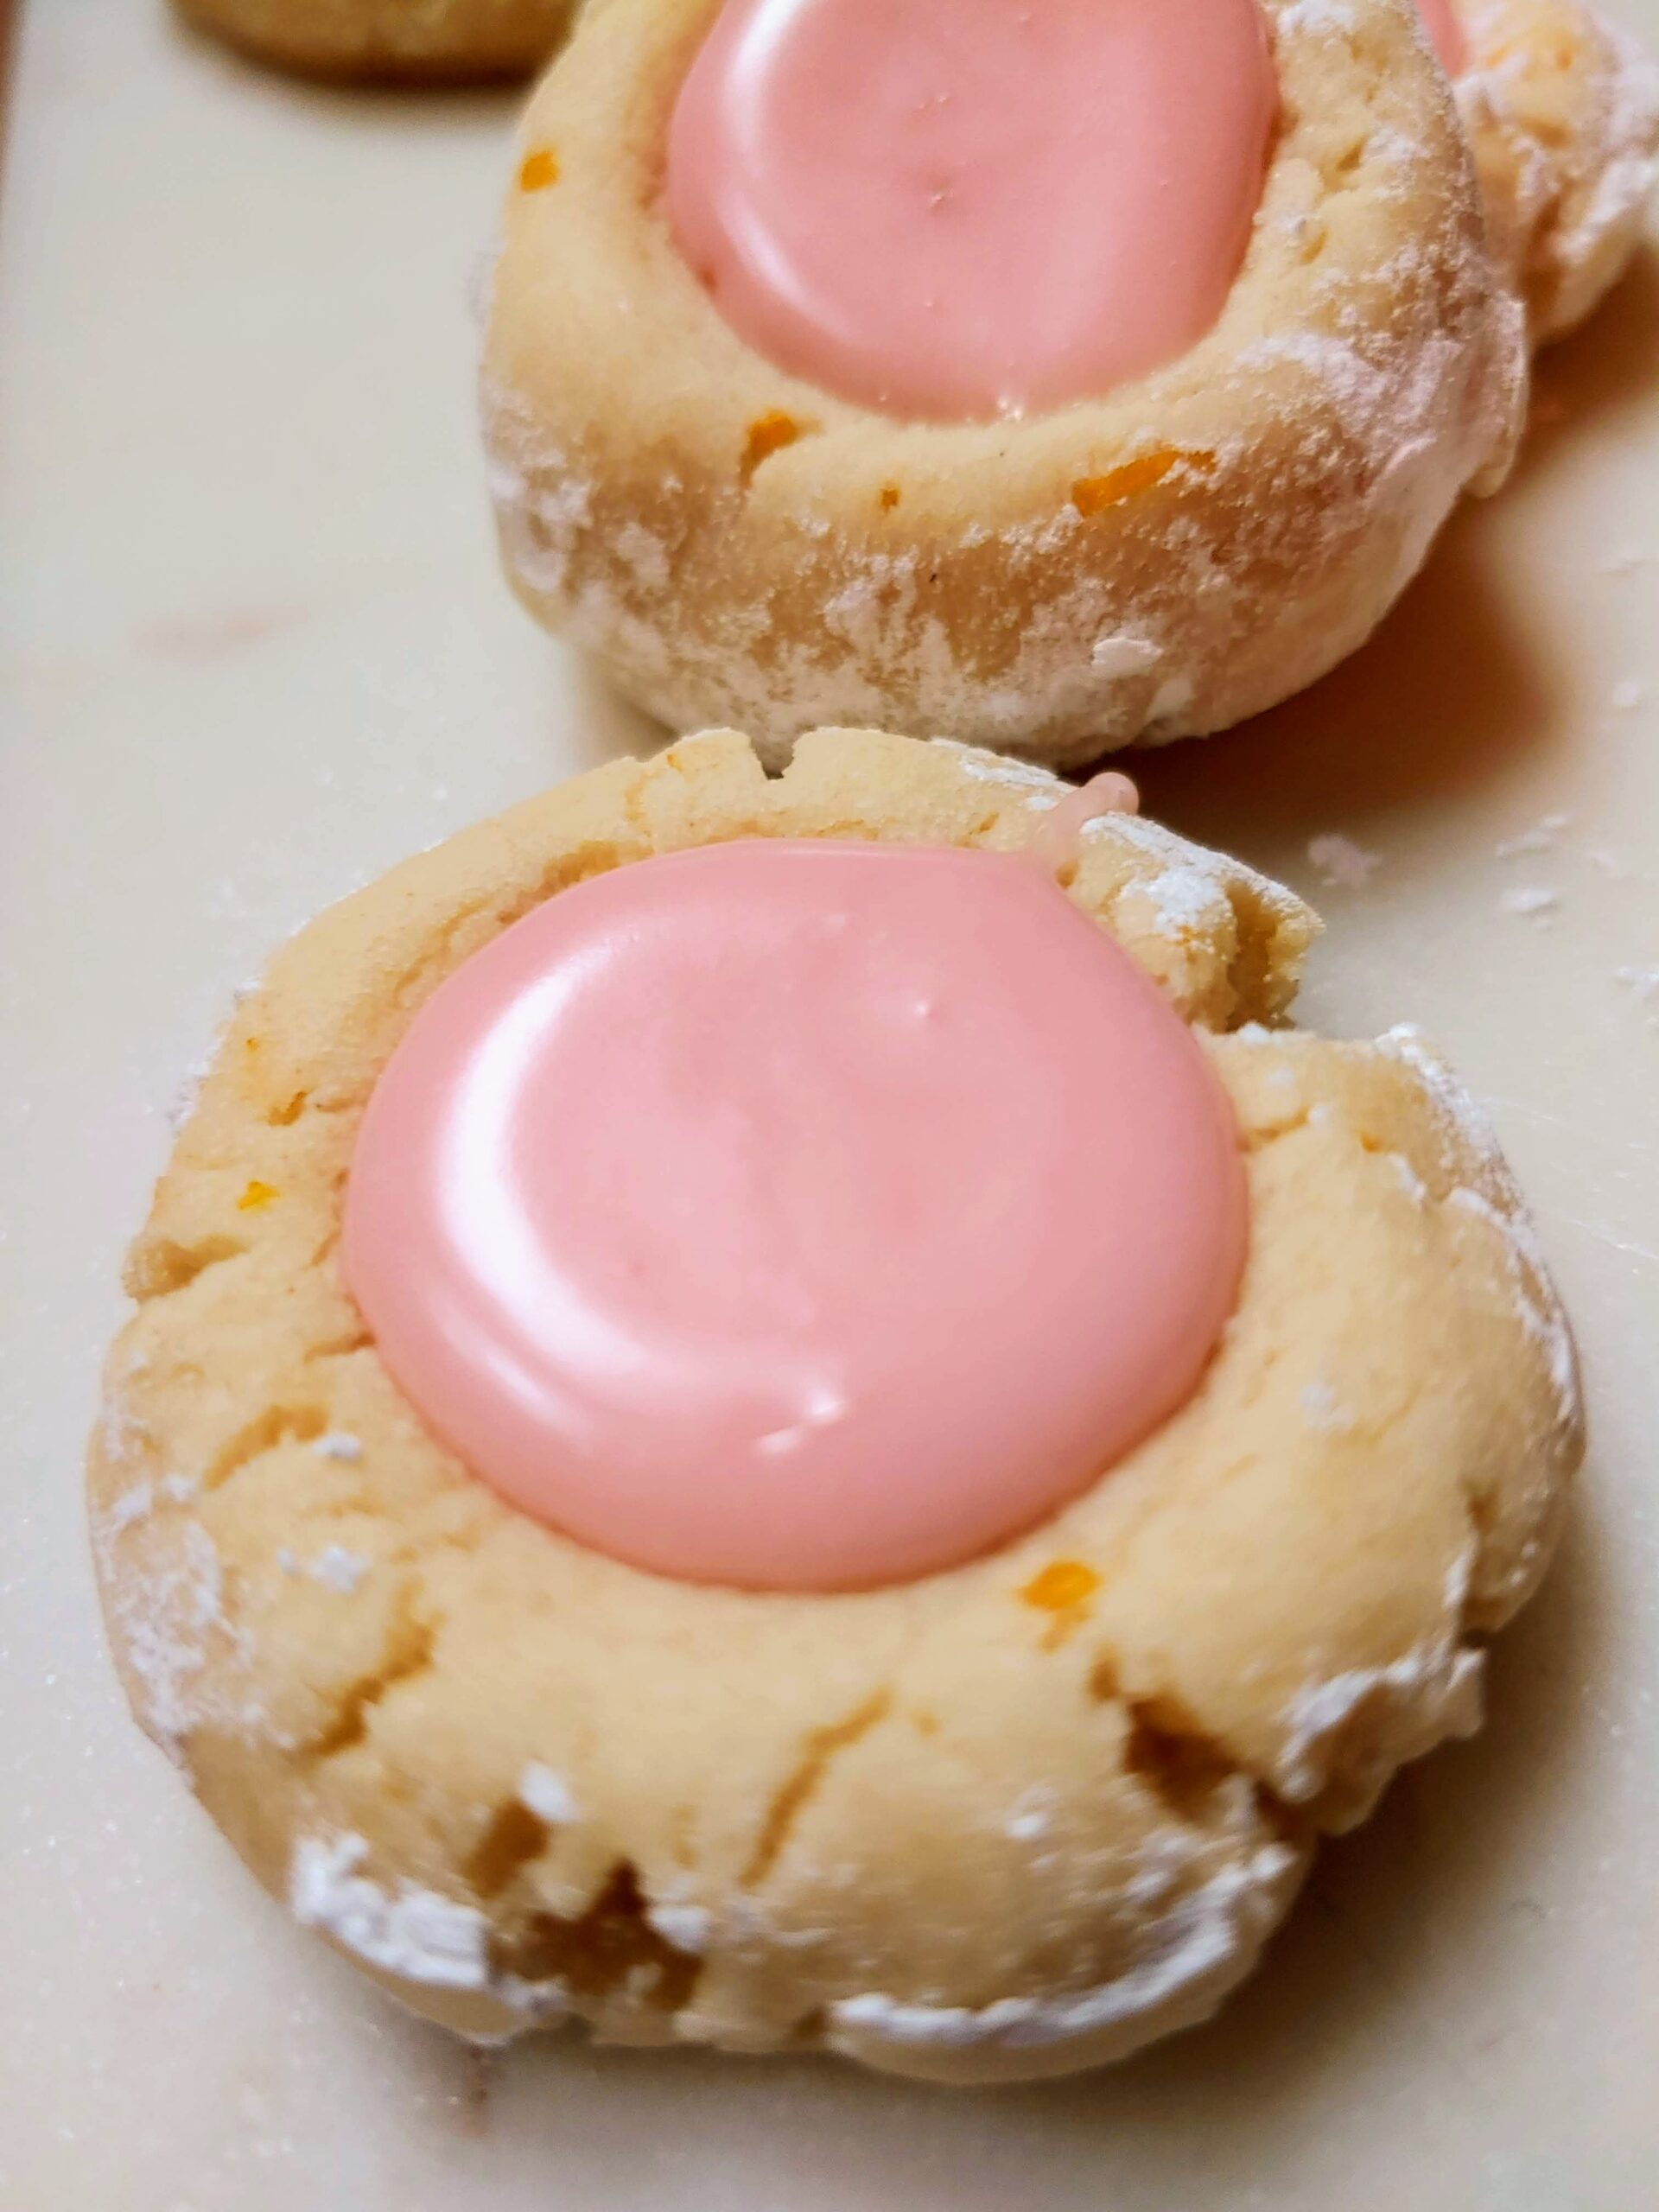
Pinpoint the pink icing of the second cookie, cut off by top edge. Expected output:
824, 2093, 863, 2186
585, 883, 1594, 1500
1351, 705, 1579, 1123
668, 0, 1279, 420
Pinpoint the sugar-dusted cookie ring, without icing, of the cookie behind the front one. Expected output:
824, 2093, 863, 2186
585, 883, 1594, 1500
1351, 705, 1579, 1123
482, 0, 1524, 766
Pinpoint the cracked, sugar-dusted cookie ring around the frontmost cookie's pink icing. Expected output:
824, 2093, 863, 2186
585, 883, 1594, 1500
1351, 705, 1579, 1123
91, 730, 1581, 2079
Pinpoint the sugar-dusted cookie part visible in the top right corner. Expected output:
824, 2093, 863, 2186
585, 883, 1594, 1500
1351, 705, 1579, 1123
1449, 0, 1659, 345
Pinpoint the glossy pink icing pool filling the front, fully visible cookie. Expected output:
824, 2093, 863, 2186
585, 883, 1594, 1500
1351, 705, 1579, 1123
345, 841, 1245, 1591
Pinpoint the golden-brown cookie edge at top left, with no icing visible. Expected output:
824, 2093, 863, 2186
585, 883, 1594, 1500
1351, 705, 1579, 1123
173, 0, 580, 84
